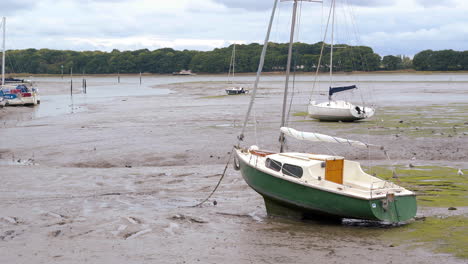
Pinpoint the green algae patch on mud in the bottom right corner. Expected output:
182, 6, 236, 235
381, 216, 468, 258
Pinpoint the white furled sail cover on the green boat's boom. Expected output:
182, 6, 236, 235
281, 127, 382, 148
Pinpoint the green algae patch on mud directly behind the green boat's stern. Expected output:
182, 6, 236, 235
366, 165, 468, 207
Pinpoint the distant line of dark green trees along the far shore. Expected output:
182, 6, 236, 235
6, 42, 468, 74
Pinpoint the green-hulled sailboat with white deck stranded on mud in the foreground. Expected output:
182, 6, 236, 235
234, 0, 417, 223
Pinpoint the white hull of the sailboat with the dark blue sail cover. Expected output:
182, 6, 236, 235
308, 101, 375, 122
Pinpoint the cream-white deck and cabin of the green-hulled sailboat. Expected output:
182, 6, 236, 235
239, 150, 413, 199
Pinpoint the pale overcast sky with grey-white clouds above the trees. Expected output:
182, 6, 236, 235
0, 0, 468, 56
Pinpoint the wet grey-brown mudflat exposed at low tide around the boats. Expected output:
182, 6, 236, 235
0, 74, 468, 263
